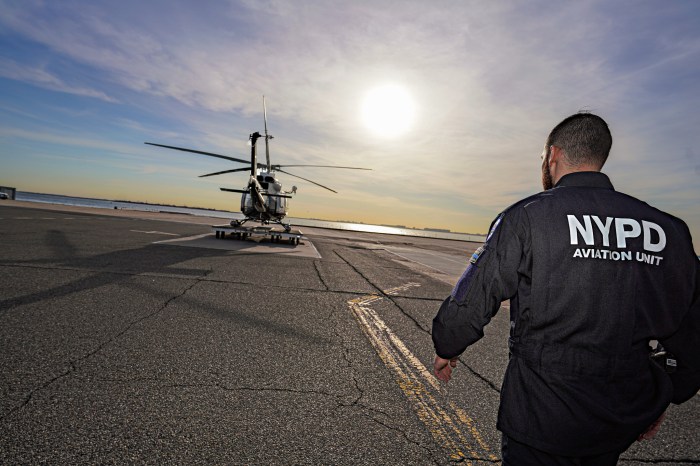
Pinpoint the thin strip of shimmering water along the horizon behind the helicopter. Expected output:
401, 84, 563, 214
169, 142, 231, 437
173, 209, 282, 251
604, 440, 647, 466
16, 191, 485, 242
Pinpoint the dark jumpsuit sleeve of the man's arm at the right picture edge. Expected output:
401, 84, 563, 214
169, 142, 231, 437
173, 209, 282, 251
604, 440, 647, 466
661, 258, 700, 404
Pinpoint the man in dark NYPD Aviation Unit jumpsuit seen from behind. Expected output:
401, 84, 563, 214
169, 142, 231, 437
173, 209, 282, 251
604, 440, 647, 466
432, 113, 700, 466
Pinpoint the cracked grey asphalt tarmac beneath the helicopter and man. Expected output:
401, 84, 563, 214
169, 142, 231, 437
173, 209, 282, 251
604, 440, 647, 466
0, 201, 700, 465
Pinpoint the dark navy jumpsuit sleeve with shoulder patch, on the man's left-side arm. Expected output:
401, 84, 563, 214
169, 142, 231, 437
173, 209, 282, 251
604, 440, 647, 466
432, 211, 524, 359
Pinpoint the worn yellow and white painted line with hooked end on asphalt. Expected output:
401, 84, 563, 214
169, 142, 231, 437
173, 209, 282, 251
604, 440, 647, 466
348, 283, 498, 464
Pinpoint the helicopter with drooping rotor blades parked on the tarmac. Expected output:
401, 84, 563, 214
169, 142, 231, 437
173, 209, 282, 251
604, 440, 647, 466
144, 96, 371, 232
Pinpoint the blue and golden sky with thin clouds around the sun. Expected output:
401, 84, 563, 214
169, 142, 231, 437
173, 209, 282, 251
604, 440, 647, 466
0, 0, 700, 244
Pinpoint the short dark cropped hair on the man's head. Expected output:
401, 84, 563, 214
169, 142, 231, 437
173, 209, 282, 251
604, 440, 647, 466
547, 112, 612, 168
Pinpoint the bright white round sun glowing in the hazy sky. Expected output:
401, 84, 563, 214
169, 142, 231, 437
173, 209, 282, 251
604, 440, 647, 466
362, 84, 416, 138
